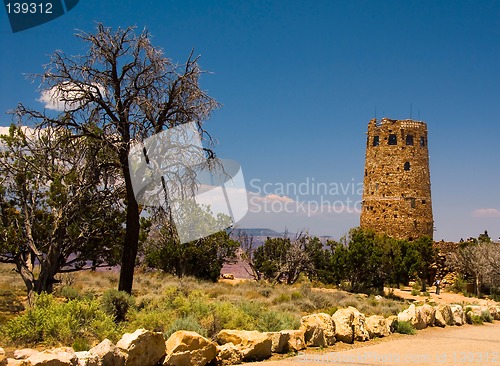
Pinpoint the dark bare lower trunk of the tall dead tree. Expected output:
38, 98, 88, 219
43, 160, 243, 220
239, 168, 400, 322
118, 159, 141, 294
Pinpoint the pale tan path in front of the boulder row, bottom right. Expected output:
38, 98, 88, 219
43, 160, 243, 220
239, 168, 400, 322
252, 321, 500, 366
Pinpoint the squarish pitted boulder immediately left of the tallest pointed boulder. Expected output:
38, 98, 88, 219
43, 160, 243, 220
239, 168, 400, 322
300, 313, 335, 347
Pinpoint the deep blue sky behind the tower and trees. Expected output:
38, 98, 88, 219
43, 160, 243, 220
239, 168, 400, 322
0, 0, 500, 240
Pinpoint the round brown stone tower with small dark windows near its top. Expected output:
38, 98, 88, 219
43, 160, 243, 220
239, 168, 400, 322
361, 118, 434, 240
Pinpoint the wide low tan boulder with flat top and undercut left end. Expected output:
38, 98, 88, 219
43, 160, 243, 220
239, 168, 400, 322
216, 329, 273, 361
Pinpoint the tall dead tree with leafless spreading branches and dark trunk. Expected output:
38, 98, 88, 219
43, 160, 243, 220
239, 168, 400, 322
10, 24, 219, 293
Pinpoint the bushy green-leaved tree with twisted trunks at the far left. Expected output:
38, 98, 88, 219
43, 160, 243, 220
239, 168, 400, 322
0, 126, 125, 298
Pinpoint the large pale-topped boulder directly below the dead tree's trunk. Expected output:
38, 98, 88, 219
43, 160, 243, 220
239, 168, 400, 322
116, 329, 165, 366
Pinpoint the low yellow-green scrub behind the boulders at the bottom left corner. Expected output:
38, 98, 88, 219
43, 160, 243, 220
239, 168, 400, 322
3, 293, 119, 345
